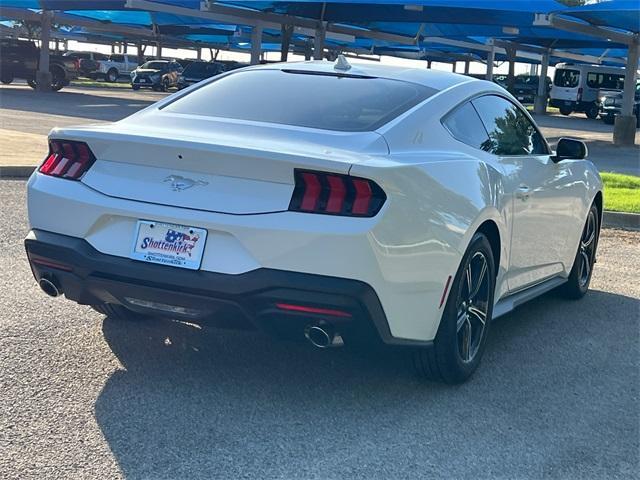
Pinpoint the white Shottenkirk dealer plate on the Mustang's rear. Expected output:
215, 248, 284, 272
131, 220, 207, 270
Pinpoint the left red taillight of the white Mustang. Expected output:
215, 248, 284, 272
38, 140, 96, 180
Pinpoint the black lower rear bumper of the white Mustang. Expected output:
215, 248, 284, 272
25, 230, 420, 345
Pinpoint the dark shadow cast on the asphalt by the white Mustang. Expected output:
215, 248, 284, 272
95, 291, 640, 479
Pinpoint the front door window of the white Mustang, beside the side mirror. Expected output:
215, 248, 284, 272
471, 95, 549, 156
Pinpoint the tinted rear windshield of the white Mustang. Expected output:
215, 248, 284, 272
164, 70, 436, 132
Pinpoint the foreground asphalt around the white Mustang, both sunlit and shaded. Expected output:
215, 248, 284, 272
0, 180, 640, 479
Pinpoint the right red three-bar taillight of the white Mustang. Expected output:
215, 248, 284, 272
289, 170, 387, 217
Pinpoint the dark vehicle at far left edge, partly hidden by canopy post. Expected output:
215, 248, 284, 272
0, 38, 80, 91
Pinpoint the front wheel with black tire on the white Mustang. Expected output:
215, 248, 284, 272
559, 204, 600, 300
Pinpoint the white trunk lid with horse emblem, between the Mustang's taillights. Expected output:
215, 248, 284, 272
55, 111, 388, 215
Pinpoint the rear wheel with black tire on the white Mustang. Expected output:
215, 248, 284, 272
413, 233, 496, 384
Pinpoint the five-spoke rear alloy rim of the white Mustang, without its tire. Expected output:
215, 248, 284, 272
456, 252, 490, 363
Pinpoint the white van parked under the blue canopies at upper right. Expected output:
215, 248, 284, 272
549, 63, 624, 119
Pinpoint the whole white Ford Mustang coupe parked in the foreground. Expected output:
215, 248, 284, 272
25, 58, 602, 383
